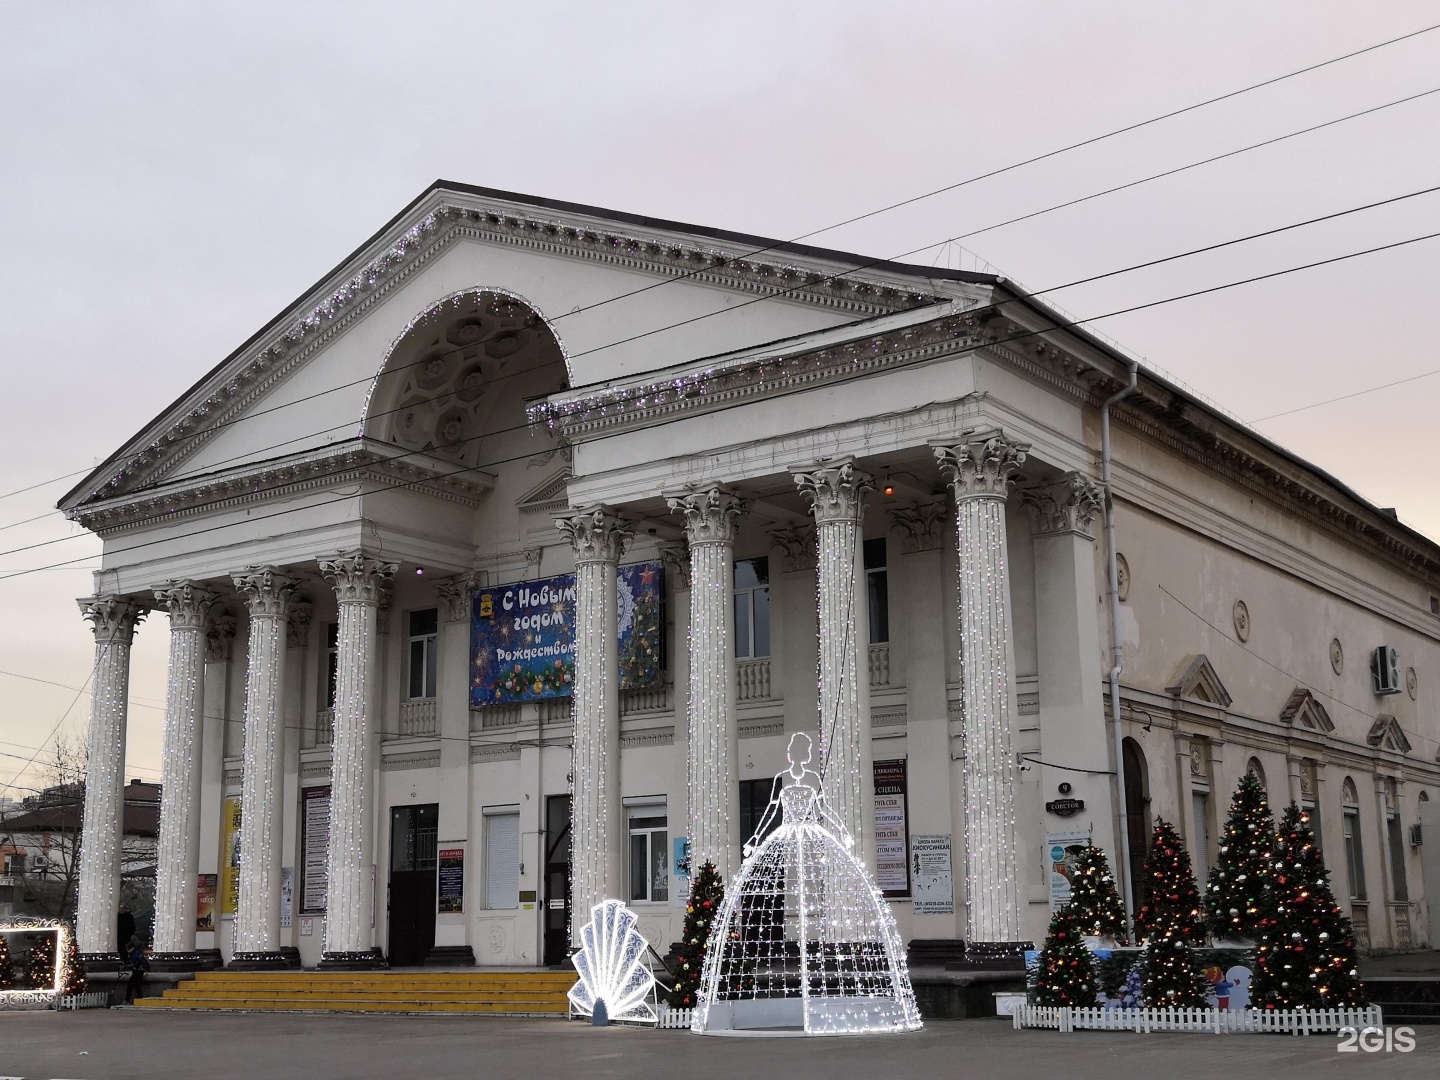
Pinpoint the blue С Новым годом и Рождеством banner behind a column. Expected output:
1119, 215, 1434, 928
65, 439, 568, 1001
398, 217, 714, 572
469, 563, 664, 708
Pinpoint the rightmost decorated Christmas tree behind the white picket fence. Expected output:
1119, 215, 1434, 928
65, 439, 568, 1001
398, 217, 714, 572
1250, 802, 1365, 1009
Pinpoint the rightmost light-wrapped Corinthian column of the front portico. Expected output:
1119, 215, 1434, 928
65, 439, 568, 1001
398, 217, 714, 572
933, 431, 1030, 953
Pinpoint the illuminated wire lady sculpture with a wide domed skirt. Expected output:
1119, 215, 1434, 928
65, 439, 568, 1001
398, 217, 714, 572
691, 734, 920, 1035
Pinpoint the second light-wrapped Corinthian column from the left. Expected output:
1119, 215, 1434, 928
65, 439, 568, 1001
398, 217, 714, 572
154, 582, 219, 962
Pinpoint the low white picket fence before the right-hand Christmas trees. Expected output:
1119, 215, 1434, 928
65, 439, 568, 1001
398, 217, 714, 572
1014, 1005, 1384, 1035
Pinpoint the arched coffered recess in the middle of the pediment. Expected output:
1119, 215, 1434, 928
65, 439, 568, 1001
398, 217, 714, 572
360, 287, 569, 469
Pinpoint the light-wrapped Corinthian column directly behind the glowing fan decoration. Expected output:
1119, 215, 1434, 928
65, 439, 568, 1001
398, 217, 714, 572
556, 507, 631, 922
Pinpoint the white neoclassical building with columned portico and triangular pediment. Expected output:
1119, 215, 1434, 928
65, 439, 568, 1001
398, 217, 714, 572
62, 183, 1440, 966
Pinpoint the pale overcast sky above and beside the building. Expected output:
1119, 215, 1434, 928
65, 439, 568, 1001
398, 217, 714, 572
0, 0, 1440, 796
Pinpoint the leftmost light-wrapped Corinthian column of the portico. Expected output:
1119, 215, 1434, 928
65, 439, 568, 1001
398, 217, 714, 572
75, 596, 145, 963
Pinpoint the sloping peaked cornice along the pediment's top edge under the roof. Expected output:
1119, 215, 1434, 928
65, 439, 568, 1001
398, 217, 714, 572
73, 192, 967, 505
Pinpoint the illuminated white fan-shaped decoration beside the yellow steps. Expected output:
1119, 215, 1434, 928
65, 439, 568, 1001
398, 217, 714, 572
569, 900, 657, 1024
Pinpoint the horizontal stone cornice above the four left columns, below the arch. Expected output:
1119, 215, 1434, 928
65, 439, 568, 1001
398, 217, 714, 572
66, 439, 494, 537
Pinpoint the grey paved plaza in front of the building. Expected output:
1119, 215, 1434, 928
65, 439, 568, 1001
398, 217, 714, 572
0, 1009, 1440, 1080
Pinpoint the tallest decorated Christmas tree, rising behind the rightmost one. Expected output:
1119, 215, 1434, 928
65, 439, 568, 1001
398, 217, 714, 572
1205, 772, 1274, 937
